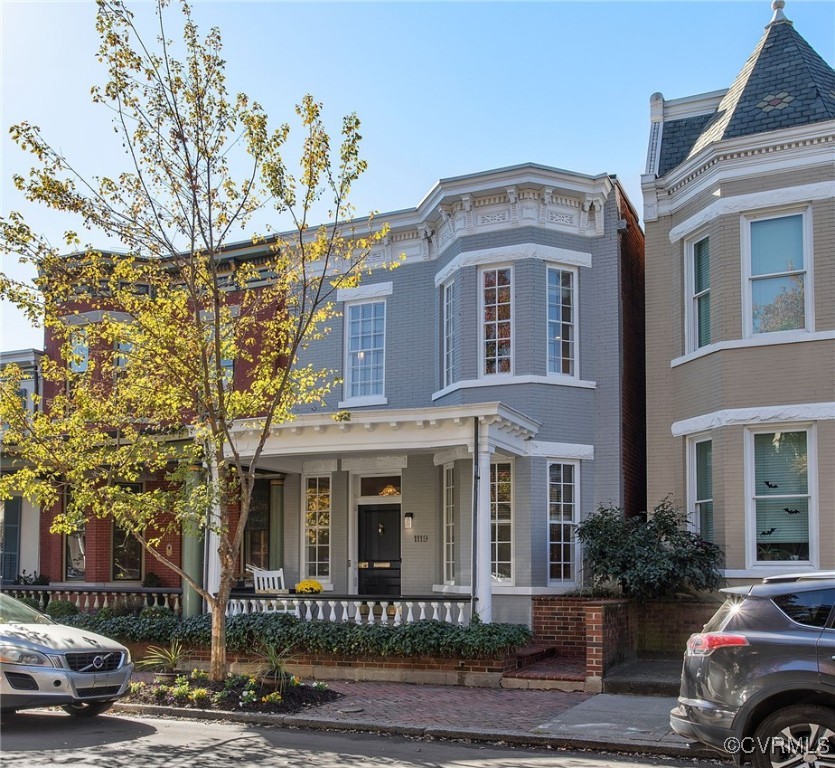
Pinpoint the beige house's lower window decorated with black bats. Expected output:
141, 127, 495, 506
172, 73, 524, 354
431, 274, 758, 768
747, 428, 813, 562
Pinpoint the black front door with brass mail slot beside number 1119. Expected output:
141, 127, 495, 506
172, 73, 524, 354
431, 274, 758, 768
357, 504, 400, 595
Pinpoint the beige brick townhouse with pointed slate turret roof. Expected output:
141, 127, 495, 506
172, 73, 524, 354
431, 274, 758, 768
642, 0, 835, 580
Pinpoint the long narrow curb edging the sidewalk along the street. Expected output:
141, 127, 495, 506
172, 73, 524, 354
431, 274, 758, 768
111, 703, 717, 759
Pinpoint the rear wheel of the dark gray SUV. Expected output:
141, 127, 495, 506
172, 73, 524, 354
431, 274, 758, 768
752, 704, 835, 768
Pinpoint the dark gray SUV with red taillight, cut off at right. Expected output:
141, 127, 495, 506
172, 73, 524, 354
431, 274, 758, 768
670, 573, 835, 768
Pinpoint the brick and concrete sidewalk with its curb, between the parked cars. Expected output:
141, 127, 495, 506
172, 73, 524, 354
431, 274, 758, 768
116, 681, 716, 757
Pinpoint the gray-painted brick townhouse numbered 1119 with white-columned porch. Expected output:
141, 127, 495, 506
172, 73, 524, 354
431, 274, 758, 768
235, 164, 645, 622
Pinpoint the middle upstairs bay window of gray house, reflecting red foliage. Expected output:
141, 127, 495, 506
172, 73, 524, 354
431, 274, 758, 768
481, 267, 513, 375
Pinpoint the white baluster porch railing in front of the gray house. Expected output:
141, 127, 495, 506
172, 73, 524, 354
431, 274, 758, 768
226, 594, 472, 626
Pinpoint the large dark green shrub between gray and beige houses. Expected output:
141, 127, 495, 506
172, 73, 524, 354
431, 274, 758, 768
577, 497, 722, 600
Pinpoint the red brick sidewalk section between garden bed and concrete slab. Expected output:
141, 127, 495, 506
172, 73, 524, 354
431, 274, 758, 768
304, 680, 591, 733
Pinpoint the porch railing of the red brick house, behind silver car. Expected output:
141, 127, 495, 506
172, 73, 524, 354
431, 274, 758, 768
2, 584, 183, 613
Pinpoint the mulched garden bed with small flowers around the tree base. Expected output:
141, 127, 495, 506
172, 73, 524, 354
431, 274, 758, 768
122, 670, 342, 714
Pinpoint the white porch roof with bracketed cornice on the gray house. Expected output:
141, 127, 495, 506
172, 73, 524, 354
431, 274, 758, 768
230, 402, 541, 471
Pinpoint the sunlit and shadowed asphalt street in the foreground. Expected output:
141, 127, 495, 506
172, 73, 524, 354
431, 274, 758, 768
0, 710, 720, 768
